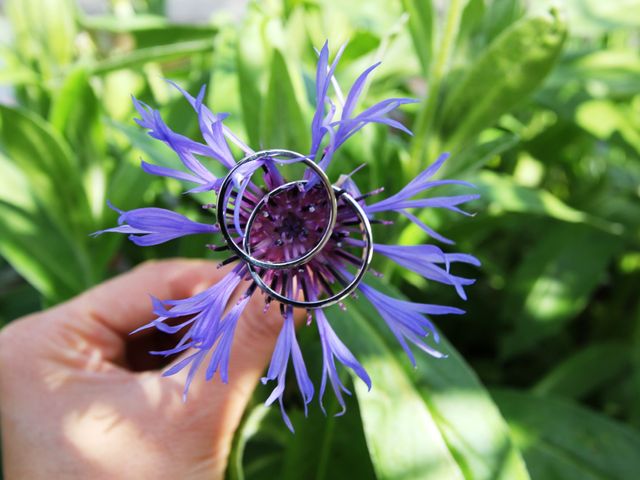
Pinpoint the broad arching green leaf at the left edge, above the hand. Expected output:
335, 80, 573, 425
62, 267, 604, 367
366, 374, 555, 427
0, 105, 102, 302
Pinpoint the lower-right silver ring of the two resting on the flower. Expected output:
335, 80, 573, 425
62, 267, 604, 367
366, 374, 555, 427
243, 186, 373, 309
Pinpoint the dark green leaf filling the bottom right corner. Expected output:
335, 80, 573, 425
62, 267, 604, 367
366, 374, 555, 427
492, 390, 640, 480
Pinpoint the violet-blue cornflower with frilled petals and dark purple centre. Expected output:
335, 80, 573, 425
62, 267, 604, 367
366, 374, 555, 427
96, 44, 479, 430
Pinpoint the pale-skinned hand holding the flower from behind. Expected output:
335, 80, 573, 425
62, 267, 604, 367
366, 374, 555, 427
0, 260, 296, 480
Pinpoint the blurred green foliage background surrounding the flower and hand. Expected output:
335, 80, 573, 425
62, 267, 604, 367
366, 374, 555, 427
0, 0, 640, 480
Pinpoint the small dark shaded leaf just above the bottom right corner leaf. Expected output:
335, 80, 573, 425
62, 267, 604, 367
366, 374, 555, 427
533, 342, 631, 399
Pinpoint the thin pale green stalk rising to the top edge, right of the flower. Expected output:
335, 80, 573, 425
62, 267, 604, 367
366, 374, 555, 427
409, 0, 464, 172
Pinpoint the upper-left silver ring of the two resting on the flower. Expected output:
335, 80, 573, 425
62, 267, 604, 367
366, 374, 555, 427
216, 150, 338, 270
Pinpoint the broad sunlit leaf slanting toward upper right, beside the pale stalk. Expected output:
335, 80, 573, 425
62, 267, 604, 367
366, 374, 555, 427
442, 11, 566, 149
